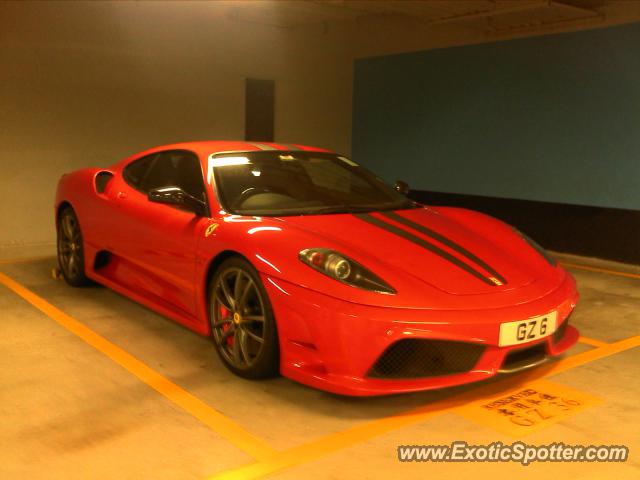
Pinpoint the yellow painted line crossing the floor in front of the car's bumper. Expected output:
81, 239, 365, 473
211, 336, 640, 480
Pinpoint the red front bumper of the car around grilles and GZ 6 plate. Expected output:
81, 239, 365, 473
263, 275, 579, 396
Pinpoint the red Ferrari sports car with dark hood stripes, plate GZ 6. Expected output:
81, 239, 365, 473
55, 141, 578, 395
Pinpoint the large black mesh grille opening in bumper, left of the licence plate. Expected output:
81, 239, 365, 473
368, 338, 485, 379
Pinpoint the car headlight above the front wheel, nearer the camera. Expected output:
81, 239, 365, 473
298, 248, 397, 295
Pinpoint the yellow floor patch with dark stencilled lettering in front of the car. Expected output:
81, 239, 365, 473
456, 380, 602, 437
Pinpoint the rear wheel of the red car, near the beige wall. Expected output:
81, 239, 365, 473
57, 207, 91, 287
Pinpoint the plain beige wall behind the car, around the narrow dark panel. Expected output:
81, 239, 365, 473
0, 2, 352, 257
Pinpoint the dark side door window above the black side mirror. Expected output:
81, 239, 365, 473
140, 150, 207, 202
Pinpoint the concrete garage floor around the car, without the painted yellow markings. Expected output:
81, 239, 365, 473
0, 256, 640, 479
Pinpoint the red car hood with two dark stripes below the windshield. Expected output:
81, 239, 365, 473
272, 208, 560, 295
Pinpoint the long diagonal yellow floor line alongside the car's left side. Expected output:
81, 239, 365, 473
0, 272, 277, 460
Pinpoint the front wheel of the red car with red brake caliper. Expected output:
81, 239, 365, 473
209, 257, 280, 379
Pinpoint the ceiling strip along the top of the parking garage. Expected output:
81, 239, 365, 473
212, 0, 640, 33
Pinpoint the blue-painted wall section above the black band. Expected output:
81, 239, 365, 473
353, 23, 640, 210
